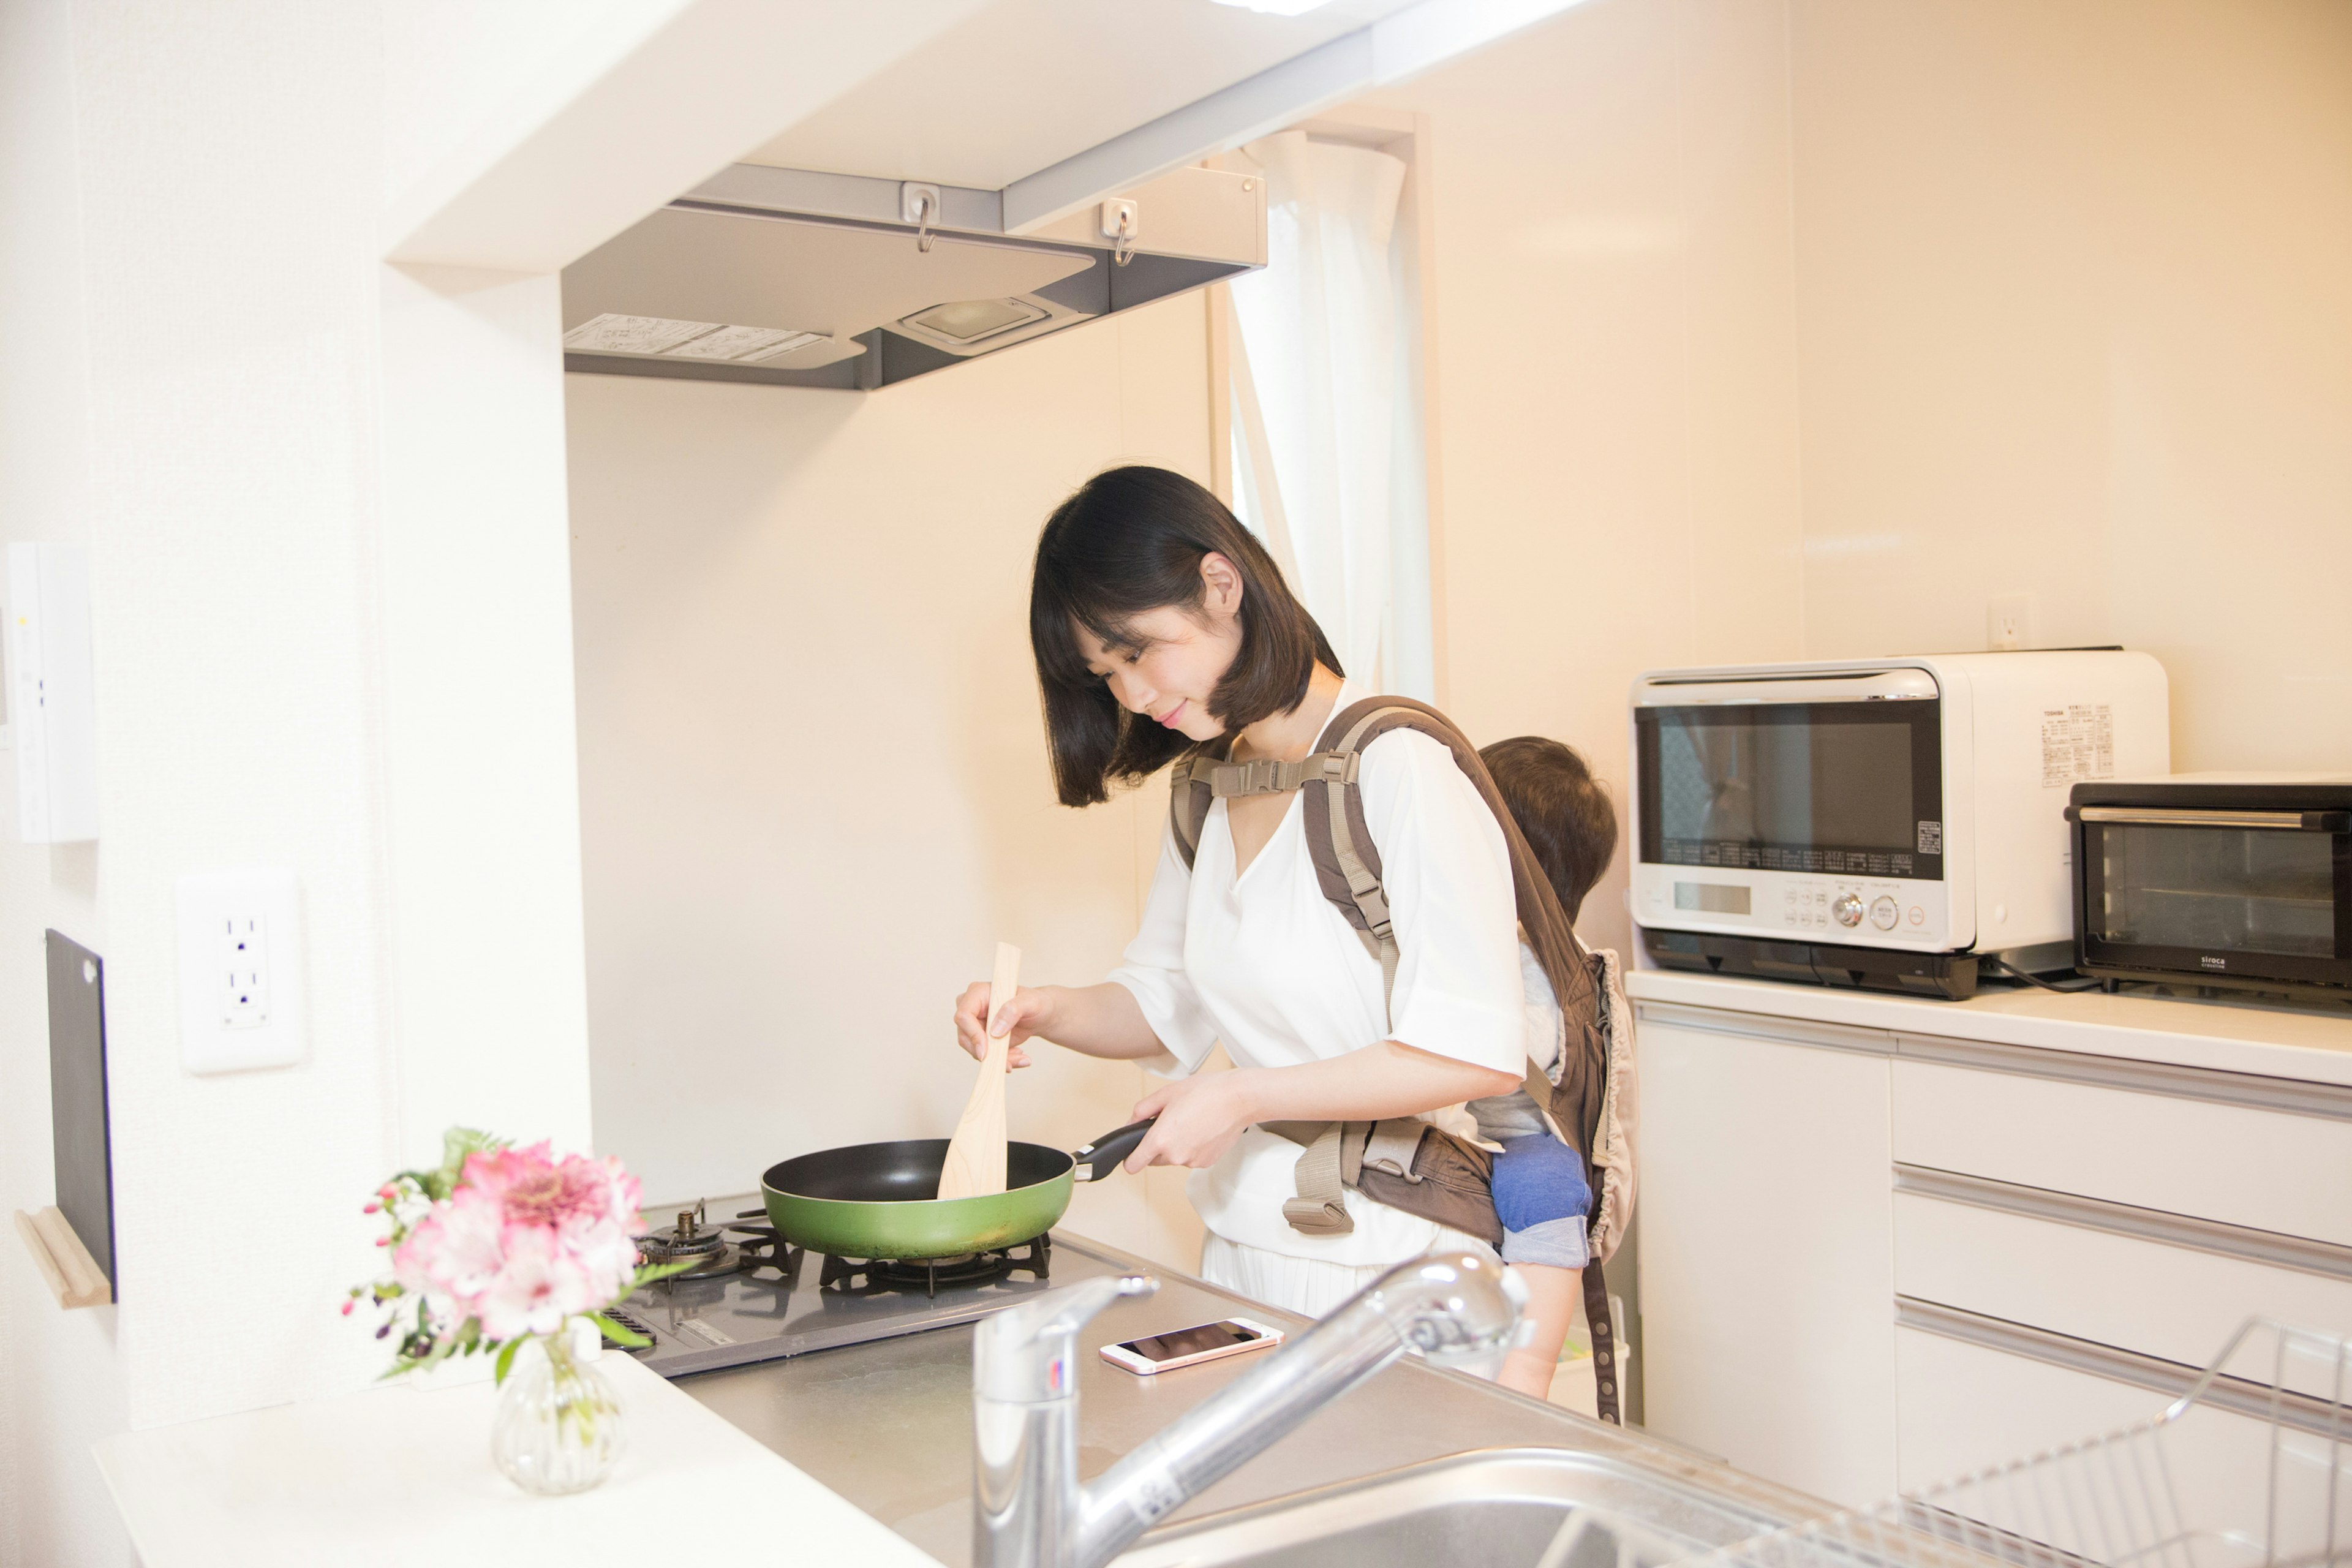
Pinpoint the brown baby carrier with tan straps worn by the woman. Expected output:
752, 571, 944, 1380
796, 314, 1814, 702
1169, 696, 1635, 1422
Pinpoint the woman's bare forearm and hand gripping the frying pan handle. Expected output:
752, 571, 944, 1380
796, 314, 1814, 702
1124, 1048, 1520, 1170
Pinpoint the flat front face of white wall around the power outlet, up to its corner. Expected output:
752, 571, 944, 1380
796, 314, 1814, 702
0, 5, 404, 1563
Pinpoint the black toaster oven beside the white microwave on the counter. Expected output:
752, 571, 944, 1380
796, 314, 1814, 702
2067, 774, 2352, 1001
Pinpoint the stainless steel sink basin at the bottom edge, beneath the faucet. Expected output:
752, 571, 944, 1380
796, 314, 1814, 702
1112, 1448, 1795, 1568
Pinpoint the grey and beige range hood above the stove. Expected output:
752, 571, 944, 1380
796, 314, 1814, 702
565, 165, 1265, 393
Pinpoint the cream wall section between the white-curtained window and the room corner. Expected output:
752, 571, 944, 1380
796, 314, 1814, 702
1376, 0, 1804, 950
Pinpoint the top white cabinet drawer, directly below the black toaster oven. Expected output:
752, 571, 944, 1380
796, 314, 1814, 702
1893, 1058, 2352, 1246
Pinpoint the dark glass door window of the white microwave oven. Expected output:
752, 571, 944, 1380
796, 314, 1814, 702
1635, 701, 1943, 879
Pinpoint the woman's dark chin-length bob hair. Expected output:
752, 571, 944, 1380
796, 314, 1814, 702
1030, 468, 1345, 806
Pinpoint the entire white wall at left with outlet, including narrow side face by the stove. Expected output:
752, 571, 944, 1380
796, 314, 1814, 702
0, 0, 616, 1566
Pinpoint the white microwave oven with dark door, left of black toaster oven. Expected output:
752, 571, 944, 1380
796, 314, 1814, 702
1630, 649, 2171, 997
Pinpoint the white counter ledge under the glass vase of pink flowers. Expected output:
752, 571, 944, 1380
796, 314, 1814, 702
96, 1357, 936, 1568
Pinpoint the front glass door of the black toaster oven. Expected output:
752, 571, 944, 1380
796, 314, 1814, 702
2081, 809, 2352, 985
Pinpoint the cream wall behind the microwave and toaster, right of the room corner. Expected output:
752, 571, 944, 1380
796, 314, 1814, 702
1795, 0, 2352, 771
